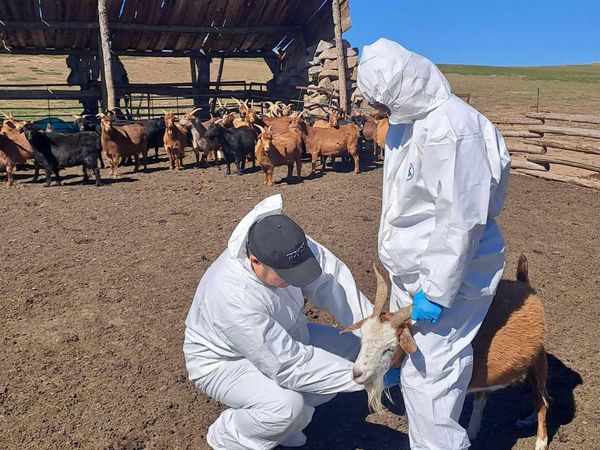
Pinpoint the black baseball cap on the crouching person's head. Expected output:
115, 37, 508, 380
248, 214, 322, 287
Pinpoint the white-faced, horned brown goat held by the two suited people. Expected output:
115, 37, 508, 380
344, 255, 548, 450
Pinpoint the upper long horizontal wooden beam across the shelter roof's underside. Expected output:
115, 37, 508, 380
0, 20, 302, 34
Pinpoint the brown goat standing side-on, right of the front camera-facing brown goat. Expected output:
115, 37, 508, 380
304, 124, 360, 175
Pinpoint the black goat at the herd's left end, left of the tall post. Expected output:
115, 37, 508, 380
21, 123, 102, 187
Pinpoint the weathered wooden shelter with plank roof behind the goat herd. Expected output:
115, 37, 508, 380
0, 0, 351, 118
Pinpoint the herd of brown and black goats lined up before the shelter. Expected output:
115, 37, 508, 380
0, 99, 388, 186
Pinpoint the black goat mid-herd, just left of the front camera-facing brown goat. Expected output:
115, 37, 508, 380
204, 125, 256, 175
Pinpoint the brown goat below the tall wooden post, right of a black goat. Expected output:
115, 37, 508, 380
98, 114, 148, 178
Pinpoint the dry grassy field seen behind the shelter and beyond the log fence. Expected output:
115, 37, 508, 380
0, 55, 600, 119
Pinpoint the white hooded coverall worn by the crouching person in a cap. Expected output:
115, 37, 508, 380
183, 195, 372, 450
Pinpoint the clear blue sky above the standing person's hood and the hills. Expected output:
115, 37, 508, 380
344, 0, 600, 66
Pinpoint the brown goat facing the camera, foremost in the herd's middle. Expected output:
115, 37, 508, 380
254, 119, 302, 186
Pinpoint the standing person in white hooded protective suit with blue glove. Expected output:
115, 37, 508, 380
358, 39, 510, 450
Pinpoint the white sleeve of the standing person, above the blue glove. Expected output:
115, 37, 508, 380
419, 137, 492, 308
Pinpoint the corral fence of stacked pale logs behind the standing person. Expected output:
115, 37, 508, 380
492, 112, 600, 189
